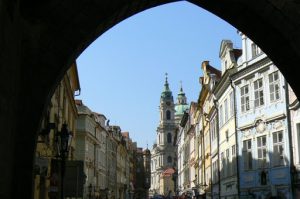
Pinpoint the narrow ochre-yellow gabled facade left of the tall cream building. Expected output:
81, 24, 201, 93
198, 61, 221, 198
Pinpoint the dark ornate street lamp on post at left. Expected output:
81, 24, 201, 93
55, 123, 72, 199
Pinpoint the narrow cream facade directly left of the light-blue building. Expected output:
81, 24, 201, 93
211, 40, 242, 199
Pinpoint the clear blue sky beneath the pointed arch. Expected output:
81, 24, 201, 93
77, 2, 241, 148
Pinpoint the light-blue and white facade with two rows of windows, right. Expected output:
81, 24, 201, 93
232, 34, 291, 199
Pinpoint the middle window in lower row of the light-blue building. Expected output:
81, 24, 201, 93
257, 136, 267, 168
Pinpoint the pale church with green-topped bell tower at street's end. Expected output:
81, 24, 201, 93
150, 74, 188, 195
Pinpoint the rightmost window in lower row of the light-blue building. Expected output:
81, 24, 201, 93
273, 131, 284, 166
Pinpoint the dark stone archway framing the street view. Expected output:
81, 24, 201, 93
0, 0, 300, 198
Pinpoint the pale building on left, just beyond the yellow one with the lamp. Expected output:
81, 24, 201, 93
75, 101, 107, 197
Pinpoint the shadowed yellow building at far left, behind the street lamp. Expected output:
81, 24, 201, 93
34, 63, 80, 199
